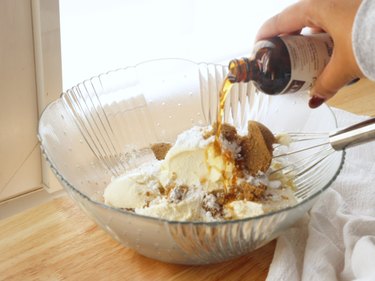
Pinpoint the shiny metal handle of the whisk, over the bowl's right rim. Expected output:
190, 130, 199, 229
329, 118, 375, 150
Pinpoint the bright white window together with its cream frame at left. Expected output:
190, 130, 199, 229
0, 0, 295, 215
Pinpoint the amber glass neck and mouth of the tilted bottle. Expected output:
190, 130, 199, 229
228, 58, 259, 83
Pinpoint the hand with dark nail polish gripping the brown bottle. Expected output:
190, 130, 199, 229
256, 0, 363, 108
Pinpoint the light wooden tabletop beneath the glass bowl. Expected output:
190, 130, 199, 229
0, 77, 375, 281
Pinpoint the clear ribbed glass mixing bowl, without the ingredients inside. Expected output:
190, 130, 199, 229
39, 59, 344, 264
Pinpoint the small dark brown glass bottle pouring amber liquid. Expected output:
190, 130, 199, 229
228, 33, 333, 95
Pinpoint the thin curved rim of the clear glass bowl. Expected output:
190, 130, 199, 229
38, 58, 346, 226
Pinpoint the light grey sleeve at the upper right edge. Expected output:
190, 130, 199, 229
352, 0, 375, 81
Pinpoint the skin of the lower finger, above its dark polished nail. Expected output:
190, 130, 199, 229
310, 53, 355, 101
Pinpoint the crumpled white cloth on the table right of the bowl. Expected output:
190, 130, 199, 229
267, 109, 375, 281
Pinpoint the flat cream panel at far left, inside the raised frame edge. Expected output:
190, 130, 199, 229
0, 0, 42, 202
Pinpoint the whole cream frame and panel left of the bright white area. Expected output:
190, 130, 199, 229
0, 0, 62, 219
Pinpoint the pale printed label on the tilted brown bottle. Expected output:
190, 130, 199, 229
280, 34, 333, 94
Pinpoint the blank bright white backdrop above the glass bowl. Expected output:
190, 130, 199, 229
60, 0, 295, 89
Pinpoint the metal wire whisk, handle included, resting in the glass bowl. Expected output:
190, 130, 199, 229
273, 118, 375, 200
